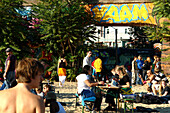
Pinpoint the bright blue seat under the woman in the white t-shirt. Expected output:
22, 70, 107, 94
75, 93, 96, 113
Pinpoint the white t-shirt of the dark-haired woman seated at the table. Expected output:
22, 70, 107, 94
76, 74, 90, 94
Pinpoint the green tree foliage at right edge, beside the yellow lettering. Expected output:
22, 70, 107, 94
145, 0, 170, 41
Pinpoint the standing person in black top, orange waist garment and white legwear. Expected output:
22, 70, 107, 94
58, 55, 67, 87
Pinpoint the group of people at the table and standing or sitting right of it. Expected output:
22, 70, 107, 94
77, 51, 170, 111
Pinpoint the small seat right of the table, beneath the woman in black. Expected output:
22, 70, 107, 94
120, 87, 134, 113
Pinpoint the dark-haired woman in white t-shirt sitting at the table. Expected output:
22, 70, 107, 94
76, 65, 104, 110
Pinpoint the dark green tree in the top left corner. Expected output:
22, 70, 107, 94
0, 0, 41, 59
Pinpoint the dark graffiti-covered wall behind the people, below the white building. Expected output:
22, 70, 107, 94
92, 48, 158, 70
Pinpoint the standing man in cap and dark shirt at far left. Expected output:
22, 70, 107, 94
3, 48, 16, 89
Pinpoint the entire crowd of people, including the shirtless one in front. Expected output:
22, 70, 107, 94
0, 48, 170, 113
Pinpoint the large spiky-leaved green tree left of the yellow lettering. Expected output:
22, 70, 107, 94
33, 0, 95, 81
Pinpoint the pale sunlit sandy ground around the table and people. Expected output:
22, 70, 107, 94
46, 82, 170, 113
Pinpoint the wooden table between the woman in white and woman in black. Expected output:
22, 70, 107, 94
96, 85, 120, 112
